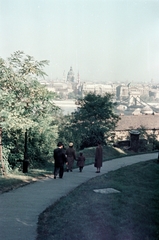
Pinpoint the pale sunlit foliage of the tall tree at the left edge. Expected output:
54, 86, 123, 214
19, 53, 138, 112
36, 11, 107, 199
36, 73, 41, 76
0, 51, 59, 170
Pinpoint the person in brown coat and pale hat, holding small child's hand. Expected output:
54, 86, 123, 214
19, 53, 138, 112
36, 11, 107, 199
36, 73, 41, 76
66, 142, 76, 172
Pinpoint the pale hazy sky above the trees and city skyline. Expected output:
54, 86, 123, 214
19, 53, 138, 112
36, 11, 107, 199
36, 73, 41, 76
0, 0, 159, 83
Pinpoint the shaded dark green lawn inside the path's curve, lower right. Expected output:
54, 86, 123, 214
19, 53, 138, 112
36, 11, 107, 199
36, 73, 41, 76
37, 160, 159, 240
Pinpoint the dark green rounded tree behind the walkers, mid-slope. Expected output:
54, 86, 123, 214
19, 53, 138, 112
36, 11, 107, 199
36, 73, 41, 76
59, 93, 119, 148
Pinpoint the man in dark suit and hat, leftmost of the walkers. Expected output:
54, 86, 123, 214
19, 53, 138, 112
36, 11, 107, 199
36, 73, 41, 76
53, 142, 67, 179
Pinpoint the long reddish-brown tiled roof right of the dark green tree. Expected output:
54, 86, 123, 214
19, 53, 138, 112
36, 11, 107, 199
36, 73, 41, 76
115, 115, 159, 130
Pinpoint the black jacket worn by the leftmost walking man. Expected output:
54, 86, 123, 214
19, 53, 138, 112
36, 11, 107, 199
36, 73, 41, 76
54, 148, 67, 167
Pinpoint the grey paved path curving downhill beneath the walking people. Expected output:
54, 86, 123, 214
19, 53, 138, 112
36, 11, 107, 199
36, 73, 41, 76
0, 153, 158, 240
